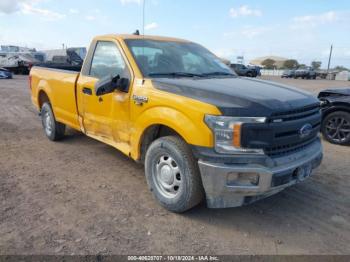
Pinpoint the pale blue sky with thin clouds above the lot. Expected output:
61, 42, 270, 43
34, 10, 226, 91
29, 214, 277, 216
0, 0, 350, 67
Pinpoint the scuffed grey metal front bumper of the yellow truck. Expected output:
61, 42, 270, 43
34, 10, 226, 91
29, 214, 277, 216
198, 139, 323, 208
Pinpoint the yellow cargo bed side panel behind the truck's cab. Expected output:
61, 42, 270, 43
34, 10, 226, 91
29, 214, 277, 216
30, 66, 80, 130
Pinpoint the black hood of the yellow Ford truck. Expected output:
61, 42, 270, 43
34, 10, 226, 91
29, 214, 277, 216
152, 77, 319, 117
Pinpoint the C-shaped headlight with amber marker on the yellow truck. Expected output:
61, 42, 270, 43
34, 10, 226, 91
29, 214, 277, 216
205, 115, 266, 154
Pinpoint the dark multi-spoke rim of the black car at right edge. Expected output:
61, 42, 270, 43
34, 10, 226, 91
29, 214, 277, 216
326, 116, 350, 143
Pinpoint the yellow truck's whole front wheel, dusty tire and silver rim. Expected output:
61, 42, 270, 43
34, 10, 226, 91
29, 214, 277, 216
145, 136, 204, 213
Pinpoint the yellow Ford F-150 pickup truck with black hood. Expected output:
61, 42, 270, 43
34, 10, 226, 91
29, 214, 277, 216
30, 35, 322, 212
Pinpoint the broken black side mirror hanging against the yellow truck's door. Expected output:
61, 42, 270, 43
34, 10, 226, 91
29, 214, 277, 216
95, 75, 129, 96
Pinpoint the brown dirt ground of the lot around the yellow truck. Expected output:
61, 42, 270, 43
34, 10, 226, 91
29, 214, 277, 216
0, 76, 350, 255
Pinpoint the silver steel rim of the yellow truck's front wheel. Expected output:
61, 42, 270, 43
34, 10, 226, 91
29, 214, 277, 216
153, 155, 183, 198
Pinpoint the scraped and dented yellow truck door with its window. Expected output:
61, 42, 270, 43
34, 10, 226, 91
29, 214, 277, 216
77, 40, 132, 151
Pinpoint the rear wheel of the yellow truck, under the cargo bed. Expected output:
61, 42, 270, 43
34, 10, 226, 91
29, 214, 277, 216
41, 102, 66, 141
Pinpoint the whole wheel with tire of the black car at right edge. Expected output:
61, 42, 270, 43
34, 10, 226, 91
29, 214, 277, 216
321, 111, 350, 145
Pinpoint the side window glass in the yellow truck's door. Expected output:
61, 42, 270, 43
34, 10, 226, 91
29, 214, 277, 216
90, 41, 130, 79
